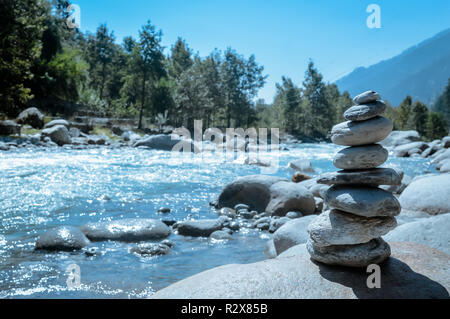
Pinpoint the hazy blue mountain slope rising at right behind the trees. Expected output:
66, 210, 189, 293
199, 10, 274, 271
336, 29, 450, 106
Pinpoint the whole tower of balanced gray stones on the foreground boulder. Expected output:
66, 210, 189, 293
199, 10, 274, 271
307, 91, 401, 267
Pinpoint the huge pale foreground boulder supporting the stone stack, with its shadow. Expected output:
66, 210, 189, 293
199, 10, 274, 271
151, 243, 450, 299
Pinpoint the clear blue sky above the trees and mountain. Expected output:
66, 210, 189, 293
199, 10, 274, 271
72, 0, 450, 102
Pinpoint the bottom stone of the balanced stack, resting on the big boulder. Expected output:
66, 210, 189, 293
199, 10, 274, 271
306, 238, 391, 267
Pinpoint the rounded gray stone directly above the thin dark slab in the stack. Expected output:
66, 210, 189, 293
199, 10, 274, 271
333, 144, 389, 169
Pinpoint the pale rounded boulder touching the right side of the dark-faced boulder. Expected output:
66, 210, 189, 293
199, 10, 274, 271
265, 182, 316, 216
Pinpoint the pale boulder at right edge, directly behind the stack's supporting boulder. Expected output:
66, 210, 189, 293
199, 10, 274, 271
384, 214, 450, 254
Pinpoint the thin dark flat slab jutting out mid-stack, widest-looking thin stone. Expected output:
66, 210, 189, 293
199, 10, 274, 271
317, 168, 402, 185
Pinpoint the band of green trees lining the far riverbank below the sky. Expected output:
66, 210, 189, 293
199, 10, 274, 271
0, 0, 450, 140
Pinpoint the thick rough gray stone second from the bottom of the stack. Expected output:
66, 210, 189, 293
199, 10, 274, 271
308, 210, 397, 247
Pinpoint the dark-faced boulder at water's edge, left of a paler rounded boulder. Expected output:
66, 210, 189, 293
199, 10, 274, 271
217, 175, 287, 212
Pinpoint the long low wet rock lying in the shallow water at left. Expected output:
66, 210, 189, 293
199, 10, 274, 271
81, 218, 171, 242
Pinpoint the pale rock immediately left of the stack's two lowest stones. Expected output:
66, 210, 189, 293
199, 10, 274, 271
273, 215, 316, 255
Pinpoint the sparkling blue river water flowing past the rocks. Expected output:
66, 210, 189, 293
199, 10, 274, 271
0, 144, 434, 298
